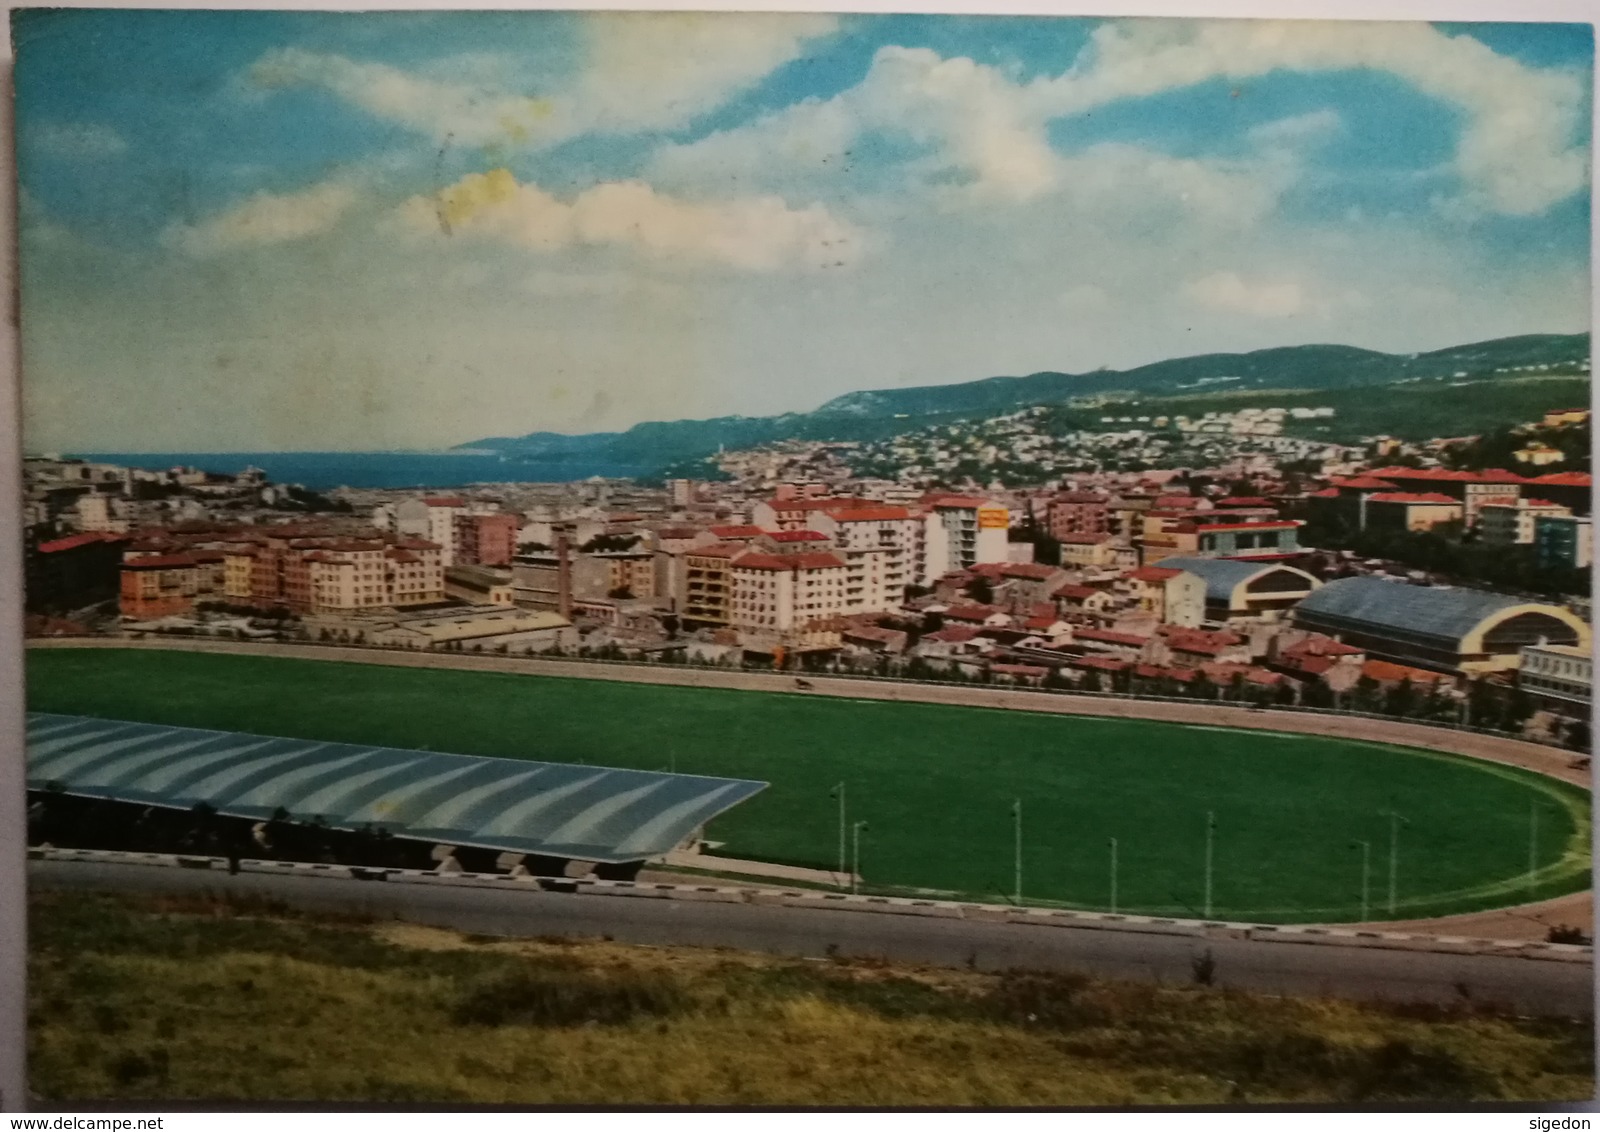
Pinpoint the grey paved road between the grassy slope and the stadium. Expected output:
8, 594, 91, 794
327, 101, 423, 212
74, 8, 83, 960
29, 860, 1594, 1015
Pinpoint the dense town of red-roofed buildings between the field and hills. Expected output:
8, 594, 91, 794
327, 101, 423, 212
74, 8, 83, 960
26, 409, 1592, 747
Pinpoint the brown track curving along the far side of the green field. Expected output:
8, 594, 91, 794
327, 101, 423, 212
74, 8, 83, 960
29, 638, 1590, 788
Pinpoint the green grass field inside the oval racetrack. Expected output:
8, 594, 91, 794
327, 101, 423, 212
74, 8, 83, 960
27, 649, 1590, 923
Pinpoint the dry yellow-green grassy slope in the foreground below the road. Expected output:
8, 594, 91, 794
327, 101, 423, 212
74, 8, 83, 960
29, 891, 1594, 1106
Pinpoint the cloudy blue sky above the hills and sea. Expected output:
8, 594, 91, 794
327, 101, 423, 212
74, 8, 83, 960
13, 10, 1592, 451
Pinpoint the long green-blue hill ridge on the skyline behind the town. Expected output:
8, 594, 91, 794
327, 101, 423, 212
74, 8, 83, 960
461, 334, 1589, 468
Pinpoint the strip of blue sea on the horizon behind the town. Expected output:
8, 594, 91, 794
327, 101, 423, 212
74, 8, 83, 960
70, 451, 643, 491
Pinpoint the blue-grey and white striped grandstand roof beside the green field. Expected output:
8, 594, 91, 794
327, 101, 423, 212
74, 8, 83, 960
27, 711, 766, 863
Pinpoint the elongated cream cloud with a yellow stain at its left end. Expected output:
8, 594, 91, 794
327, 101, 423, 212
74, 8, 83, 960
398, 169, 862, 272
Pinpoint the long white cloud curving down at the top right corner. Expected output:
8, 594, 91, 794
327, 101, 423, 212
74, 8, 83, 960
1029, 19, 1589, 216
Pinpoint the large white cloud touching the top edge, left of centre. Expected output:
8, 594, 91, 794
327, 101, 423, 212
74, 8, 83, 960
250, 13, 838, 149
